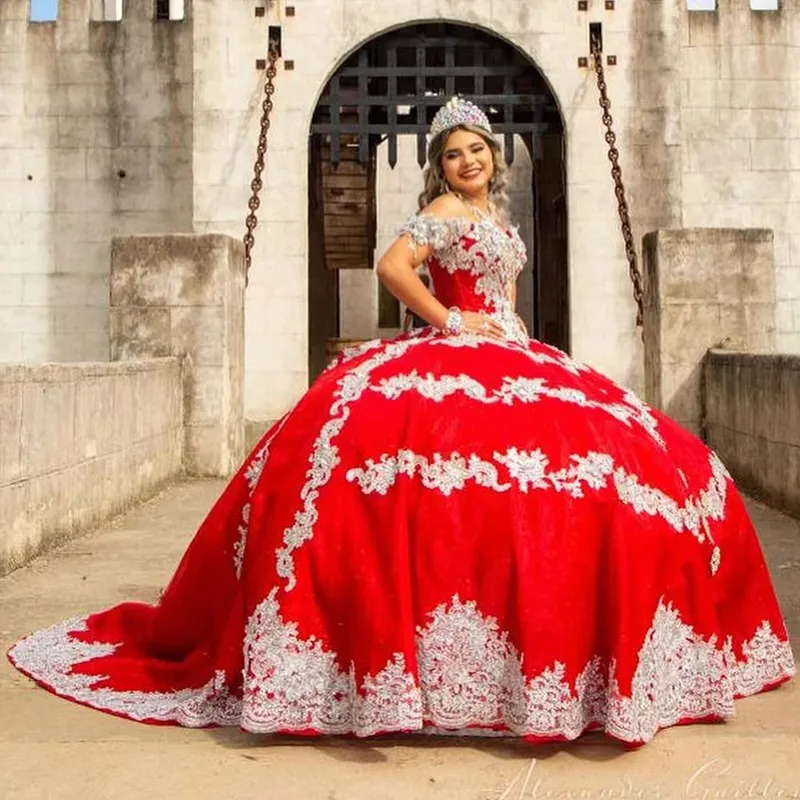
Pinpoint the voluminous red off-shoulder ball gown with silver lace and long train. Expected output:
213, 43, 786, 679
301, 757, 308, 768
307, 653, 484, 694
10, 215, 795, 744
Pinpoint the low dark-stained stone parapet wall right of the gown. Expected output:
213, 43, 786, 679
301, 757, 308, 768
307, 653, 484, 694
704, 350, 800, 516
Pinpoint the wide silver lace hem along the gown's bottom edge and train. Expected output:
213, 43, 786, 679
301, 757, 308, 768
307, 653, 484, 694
9, 589, 795, 742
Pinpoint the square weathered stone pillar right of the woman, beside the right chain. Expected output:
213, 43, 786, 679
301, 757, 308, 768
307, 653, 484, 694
643, 228, 775, 435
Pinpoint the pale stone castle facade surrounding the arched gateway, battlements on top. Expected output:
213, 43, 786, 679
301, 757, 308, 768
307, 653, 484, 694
0, 0, 800, 420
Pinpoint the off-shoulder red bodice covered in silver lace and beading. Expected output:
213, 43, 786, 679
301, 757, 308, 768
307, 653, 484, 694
400, 214, 528, 344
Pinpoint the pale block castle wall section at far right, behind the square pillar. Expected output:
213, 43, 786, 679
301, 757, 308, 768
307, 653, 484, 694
680, 0, 800, 353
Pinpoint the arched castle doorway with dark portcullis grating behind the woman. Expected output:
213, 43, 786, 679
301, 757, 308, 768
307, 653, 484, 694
308, 23, 569, 379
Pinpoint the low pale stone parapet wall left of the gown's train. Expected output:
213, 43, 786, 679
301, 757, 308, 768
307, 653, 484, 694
0, 358, 183, 575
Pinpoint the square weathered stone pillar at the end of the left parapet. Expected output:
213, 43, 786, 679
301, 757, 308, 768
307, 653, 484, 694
109, 234, 244, 477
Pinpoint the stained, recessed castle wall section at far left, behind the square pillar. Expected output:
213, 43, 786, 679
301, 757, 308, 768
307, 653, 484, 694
0, 0, 193, 362
